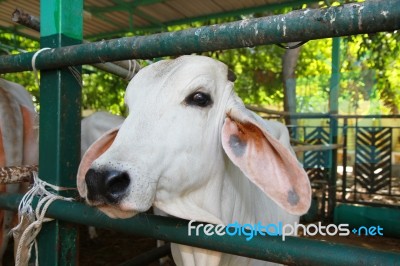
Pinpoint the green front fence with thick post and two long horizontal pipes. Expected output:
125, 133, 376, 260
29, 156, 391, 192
0, 0, 400, 265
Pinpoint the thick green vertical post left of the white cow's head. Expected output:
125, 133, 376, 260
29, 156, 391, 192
38, 0, 83, 266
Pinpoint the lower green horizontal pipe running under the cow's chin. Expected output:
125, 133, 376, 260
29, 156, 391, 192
0, 193, 400, 266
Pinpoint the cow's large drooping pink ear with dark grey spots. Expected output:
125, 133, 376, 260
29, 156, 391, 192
221, 107, 311, 215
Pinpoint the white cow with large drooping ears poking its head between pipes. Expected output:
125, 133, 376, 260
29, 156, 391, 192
77, 56, 311, 266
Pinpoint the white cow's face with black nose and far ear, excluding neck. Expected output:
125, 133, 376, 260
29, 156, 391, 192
78, 56, 233, 218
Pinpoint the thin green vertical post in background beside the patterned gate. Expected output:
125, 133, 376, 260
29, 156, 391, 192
327, 37, 340, 220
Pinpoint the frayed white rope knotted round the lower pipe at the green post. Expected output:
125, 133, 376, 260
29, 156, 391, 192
11, 173, 75, 266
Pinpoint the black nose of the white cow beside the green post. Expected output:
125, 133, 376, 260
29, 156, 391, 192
85, 169, 130, 204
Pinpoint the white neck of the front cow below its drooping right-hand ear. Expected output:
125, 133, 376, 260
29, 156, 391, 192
155, 159, 296, 228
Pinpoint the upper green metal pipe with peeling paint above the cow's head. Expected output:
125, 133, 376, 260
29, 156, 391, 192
0, 0, 400, 73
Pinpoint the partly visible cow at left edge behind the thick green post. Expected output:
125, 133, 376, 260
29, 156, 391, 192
0, 79, 39, 263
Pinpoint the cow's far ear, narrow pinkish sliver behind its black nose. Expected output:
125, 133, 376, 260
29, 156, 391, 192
77, 127, 119, 194
